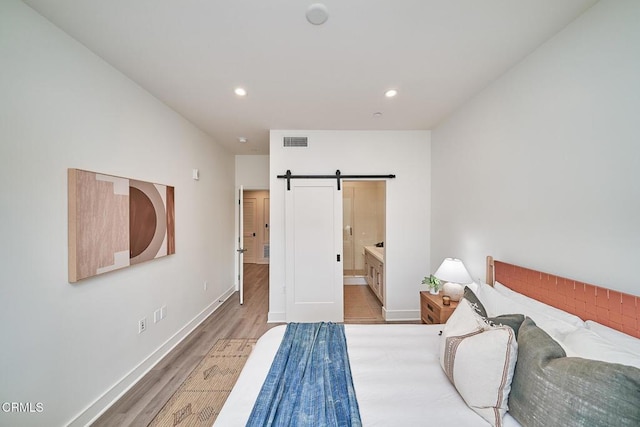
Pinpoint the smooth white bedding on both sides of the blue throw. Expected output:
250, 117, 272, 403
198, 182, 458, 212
214, 325, 519, 427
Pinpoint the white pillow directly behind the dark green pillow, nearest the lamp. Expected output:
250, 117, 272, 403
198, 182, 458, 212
477, 284, 584, 343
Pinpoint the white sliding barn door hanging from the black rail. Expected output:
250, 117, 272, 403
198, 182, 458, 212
285, 179, 344, 322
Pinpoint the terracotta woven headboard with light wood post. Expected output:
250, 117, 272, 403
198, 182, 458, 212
487, 256, 640, 338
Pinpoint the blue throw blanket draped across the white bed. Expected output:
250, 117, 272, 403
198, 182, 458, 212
247, 323, 362, 427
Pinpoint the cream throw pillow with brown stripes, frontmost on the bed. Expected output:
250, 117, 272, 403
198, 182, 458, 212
440, 299, 518, 426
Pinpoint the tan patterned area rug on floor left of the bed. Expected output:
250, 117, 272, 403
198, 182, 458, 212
149, 338, 256, 427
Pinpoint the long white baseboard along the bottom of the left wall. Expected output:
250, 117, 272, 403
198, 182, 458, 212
67, 286, 235, 427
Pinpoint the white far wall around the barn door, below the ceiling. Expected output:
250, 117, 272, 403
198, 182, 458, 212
269, 130, 430, 321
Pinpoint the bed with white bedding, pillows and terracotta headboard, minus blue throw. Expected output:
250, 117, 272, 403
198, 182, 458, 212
214, 257, 640, 427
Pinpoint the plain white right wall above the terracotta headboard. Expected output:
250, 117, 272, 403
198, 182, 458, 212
431, 0, 640, 294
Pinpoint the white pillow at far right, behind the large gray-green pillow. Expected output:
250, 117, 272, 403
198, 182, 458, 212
563, 328, 640, 368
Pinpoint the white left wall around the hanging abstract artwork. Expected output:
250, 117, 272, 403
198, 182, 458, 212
0, 0, 235, 426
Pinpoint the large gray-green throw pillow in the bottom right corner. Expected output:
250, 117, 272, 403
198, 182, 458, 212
509, 318, 640, 427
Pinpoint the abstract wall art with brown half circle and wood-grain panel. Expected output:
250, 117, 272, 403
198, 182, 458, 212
68, 169, 175, 283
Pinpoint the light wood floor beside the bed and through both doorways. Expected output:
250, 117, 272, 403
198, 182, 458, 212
93, 264, 404, 427
